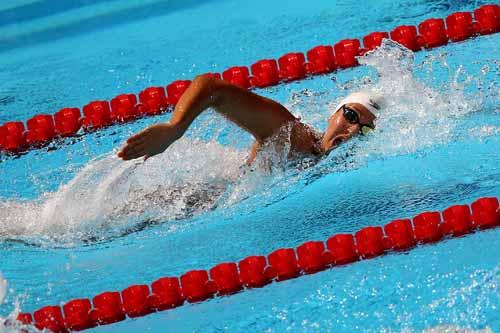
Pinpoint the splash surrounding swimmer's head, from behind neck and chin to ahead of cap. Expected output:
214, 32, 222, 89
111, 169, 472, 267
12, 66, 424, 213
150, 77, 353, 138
289, 39, 484, 179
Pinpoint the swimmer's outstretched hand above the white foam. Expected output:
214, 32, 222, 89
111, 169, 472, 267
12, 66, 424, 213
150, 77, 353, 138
118, 123, 184, 161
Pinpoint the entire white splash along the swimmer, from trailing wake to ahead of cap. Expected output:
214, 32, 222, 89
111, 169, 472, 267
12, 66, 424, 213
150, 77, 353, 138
0, 40, 488, 244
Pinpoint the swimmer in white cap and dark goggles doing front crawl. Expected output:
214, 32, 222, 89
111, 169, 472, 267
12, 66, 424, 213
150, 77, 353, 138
118, 76, 382, 164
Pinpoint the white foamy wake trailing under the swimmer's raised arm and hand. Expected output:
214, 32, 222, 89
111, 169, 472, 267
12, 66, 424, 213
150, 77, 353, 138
0, 139, 245, 243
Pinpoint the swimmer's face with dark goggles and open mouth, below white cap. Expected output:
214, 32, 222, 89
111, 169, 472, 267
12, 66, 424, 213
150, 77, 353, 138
321, 103, 375, 152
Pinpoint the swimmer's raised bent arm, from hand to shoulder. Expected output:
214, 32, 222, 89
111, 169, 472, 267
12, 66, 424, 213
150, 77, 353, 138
118, 76, 314, 160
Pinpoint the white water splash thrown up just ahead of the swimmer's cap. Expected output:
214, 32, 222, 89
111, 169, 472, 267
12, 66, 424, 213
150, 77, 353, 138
342, 39, 481, 156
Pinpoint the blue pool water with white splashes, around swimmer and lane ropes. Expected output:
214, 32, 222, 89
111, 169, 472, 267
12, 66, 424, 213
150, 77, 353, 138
0, 0, 500, 332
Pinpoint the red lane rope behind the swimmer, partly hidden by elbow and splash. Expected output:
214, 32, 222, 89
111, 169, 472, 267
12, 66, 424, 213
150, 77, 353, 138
0, 4, 500, 153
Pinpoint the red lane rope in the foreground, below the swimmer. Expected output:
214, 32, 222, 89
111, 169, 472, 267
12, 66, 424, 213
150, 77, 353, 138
8, 198, 500, 333
